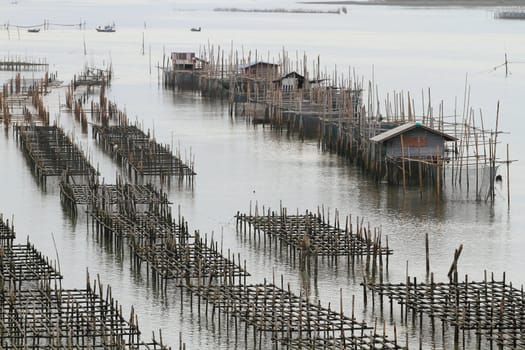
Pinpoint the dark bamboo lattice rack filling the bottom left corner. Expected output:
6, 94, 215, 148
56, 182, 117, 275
0, 277, 172, 349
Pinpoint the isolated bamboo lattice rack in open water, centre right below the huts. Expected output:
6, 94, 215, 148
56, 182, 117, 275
236, 207, 392, 269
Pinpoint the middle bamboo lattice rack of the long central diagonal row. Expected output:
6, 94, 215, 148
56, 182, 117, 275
91, 204, 248, 288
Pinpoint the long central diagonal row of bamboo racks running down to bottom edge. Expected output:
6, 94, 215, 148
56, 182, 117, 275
65, 174, 404, 349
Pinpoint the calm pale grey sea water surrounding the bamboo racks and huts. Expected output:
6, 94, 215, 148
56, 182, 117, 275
0, 0, 525, 349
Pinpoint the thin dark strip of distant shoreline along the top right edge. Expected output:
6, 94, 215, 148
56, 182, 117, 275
299, 0, 525, 7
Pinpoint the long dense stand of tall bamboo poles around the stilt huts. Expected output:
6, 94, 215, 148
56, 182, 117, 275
163, 44, 512, 203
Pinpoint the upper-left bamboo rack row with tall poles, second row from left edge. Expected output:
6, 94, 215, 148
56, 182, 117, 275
66, 64, 195, 181
